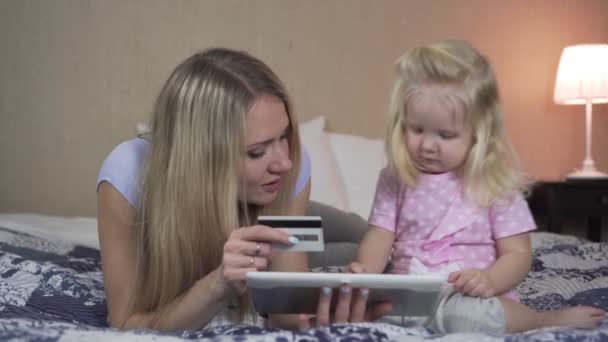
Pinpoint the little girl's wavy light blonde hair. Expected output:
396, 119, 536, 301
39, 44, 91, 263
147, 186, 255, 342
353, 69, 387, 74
386, 40, 529, 207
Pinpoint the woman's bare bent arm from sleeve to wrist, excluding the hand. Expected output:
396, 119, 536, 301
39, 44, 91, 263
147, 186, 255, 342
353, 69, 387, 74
97, 182, 232, 330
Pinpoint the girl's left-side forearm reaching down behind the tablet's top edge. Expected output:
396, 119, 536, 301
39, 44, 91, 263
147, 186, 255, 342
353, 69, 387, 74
351, 226, 395, 273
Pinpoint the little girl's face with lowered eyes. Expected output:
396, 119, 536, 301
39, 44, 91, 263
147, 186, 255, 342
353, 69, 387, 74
405, 86, 474, 173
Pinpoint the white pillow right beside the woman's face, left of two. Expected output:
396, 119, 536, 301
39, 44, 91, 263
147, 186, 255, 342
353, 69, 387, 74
300, 116, 349, 211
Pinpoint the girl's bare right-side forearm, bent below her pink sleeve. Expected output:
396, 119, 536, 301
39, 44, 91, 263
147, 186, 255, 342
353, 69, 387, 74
486, 233, 532, 295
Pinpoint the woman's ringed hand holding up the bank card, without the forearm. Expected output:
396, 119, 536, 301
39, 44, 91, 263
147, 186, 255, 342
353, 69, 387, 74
220, 225, 298, 296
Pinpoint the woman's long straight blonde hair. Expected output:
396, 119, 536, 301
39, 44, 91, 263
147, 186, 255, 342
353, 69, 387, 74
134, 48, 300, 319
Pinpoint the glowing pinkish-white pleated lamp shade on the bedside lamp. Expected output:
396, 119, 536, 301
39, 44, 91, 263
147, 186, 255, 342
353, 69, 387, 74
553, 44, 608, 104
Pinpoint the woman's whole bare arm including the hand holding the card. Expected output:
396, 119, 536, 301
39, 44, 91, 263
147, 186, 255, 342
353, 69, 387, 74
97, 182, 290, 330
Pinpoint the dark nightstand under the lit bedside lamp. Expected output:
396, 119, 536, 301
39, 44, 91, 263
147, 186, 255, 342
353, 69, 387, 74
528, 179, 608, 241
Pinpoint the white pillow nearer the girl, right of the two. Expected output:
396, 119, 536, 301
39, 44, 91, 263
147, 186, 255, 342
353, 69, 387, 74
327, 133, 386, 219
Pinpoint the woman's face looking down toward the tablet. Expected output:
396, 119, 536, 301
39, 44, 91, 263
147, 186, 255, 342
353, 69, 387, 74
243, 95, 291, 205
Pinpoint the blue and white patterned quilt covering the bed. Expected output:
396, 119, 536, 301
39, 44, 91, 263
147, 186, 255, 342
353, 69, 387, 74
0, 227, 608, 341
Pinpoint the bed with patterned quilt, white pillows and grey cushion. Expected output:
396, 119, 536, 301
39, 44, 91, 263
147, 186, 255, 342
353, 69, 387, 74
0, 118, 608, 341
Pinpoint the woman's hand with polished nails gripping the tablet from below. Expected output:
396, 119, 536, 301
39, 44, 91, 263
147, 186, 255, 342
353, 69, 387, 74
298, 285, 393, 330
